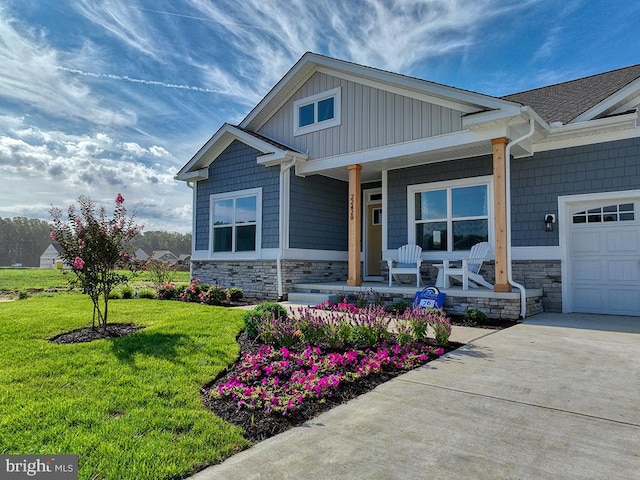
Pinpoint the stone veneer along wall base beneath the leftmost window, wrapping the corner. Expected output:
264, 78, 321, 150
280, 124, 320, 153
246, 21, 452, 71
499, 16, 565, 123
191, 260, 348, 300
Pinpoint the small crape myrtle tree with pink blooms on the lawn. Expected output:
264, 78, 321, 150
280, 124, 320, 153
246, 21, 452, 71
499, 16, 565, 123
49, 194, 142, 330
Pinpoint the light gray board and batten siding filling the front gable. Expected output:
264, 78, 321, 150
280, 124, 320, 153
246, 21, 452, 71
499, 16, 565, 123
258, 72, 462, 161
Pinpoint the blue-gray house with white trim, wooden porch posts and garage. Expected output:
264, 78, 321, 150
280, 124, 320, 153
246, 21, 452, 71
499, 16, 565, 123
176, 53, 640, 315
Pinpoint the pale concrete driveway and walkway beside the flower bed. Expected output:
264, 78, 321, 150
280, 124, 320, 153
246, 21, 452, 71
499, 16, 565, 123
191, 313, 640, 480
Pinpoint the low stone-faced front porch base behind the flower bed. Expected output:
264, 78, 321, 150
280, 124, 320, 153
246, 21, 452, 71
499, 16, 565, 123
288, 281, 543, 320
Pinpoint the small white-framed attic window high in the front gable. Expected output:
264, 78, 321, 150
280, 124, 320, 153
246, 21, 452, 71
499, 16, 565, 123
293, 87, 340, 135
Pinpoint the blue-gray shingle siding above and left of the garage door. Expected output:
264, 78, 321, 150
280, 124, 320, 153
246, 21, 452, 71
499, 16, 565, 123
511, 138, 640, 246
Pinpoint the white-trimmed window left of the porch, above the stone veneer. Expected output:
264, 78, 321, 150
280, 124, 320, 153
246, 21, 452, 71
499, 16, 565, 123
211, 188, 262, 254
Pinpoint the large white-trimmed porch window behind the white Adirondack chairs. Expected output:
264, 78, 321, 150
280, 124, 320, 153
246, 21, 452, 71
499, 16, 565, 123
407, 177, 493, 252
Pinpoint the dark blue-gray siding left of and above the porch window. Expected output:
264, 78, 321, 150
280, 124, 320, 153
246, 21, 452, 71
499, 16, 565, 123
387, 156, 493, 249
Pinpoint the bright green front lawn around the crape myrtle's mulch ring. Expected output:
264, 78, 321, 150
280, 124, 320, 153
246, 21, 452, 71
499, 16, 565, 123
0, 294, 248, 480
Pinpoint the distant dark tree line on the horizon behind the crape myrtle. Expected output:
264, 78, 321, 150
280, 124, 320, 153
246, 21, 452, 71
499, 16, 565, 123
0, 217, 191, 267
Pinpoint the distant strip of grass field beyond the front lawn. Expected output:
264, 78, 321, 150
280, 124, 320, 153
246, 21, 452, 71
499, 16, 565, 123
0, 268, 189, 292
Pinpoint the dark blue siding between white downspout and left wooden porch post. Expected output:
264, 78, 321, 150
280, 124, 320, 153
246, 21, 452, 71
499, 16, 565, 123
289, 175, 349, 251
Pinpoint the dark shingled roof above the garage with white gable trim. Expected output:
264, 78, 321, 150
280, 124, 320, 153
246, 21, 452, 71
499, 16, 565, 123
502, 65, 640, 124
